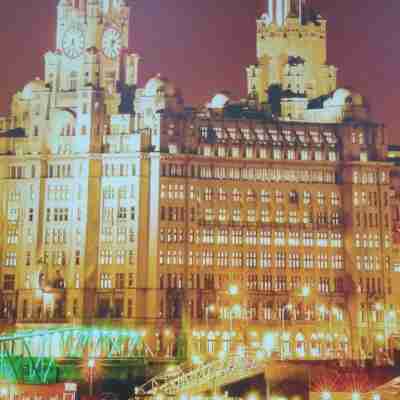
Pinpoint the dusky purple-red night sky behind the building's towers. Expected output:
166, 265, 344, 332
0, 0, 400, 143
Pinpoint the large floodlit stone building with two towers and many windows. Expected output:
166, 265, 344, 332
0, 0, 400, 359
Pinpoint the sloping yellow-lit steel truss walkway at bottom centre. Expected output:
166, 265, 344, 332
133, 351, 267, 398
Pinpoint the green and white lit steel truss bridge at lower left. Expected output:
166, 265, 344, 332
0, 327, 153, 384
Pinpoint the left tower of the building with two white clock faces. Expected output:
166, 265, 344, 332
45, 0, 139, 104
